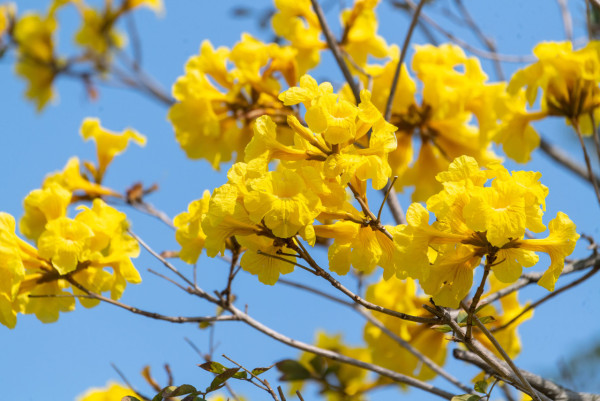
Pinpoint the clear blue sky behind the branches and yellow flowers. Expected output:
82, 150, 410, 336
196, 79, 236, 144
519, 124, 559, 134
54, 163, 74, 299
0, 0, 600, 401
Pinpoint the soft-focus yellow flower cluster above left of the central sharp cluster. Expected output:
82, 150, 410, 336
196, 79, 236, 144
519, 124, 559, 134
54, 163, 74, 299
168, 34, 301, 168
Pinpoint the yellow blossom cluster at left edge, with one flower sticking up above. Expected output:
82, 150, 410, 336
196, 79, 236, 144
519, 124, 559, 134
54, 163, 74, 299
0, 119, 145, 328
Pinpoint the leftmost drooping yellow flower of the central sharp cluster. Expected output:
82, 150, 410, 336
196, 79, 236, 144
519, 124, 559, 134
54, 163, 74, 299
173, 191, 210, 264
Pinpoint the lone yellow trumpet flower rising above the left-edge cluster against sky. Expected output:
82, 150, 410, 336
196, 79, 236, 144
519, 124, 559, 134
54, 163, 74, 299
81, 118, 146, 183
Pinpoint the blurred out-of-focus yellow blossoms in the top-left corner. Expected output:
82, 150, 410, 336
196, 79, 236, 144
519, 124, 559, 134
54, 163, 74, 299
0, 0, 163, 111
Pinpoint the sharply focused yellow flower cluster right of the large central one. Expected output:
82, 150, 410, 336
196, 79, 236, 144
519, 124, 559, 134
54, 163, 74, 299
394, 156, 579, 308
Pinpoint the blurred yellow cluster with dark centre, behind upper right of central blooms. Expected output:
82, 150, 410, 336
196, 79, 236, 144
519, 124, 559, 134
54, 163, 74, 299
344, 44, 504, 201
